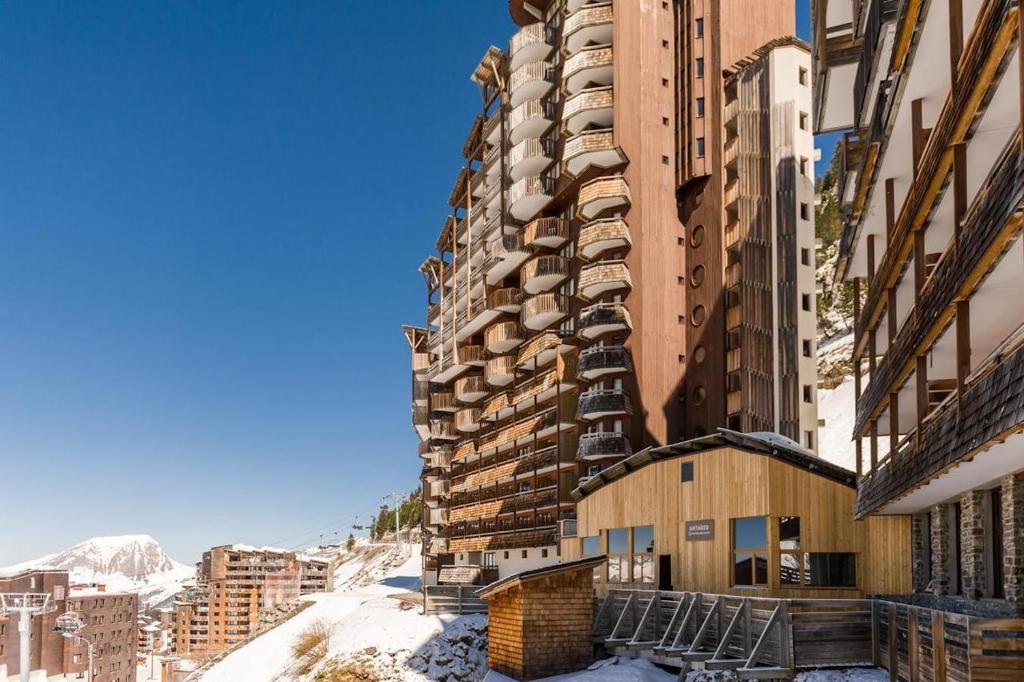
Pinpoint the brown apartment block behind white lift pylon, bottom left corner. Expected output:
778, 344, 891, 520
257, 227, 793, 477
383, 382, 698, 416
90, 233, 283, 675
0, 570, 138, 682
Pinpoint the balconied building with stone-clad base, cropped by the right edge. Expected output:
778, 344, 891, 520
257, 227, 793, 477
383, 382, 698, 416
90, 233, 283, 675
813, 0, 1024, 611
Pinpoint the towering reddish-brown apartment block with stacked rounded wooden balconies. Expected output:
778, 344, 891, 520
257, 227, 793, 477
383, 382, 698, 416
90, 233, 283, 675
404, 0, 816, 582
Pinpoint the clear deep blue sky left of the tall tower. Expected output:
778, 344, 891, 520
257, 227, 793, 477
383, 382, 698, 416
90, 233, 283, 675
0, 0, 807, 565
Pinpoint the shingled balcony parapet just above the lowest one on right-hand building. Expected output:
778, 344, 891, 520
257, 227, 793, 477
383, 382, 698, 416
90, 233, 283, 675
854, 133, 1024, 434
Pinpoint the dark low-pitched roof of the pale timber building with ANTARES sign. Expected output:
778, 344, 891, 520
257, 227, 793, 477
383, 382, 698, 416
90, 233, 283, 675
572, 428, 857, 500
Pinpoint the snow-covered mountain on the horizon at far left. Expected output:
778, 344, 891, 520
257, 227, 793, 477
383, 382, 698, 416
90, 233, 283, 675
0, 536, 195, 608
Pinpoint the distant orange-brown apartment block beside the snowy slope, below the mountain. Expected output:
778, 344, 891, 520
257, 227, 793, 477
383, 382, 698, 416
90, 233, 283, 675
174, 545, 333, 656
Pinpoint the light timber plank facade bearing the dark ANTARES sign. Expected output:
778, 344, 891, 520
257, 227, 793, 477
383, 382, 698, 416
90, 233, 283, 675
561, 439, 911, 599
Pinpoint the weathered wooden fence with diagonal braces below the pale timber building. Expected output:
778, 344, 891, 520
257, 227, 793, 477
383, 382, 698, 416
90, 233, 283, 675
594, 590, 1024, 682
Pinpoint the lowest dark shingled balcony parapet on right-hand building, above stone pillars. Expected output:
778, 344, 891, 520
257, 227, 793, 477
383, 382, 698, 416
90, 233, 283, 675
856, 339, 1024, 518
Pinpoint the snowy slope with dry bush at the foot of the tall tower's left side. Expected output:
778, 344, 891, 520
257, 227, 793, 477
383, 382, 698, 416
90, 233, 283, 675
199, 544, 486, 682
